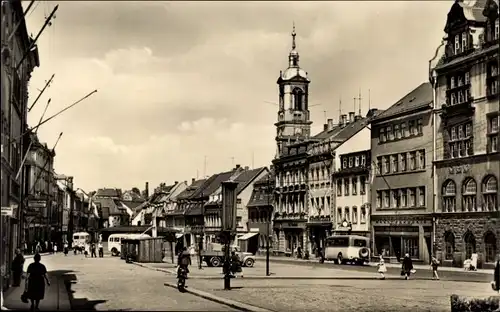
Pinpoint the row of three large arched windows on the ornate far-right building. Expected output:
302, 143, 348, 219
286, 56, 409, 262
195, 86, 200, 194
442, 175, 498, 212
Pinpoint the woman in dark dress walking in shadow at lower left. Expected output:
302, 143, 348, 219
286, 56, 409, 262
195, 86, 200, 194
26, 253, 50, 311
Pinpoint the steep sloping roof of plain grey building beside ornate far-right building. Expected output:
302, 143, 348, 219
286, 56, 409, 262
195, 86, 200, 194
372, 82, 432, 122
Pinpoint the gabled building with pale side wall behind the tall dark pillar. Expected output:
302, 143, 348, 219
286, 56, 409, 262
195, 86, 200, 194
204, 165, 268, 252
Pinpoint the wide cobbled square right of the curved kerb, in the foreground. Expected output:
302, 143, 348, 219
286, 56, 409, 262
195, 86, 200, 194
184, 279, 493, 312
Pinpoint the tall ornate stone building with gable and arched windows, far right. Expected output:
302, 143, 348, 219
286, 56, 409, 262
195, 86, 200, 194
431, 0, 500, 267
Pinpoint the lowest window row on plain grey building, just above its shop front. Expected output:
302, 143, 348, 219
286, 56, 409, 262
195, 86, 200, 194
376, 186, 425, 208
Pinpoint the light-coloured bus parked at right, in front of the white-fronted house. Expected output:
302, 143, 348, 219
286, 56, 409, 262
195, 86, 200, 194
325, 235, 370, 264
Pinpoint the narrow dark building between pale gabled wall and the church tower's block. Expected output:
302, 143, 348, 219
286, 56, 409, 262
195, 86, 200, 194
247, 168, 275, 252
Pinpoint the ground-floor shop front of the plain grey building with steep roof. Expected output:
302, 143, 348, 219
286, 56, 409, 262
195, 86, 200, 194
372, 215, 432, 263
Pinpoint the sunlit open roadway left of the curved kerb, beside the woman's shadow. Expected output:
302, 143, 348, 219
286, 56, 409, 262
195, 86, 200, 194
31, 254, 238, 311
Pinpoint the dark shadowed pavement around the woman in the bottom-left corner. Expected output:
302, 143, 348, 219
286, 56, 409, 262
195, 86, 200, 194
3, 254, 71, 311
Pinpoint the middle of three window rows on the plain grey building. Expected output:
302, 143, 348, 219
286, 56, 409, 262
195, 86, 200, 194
377, 150, 425, 175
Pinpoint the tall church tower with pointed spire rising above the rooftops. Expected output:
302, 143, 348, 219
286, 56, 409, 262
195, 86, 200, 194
274, 24, 312, 157
